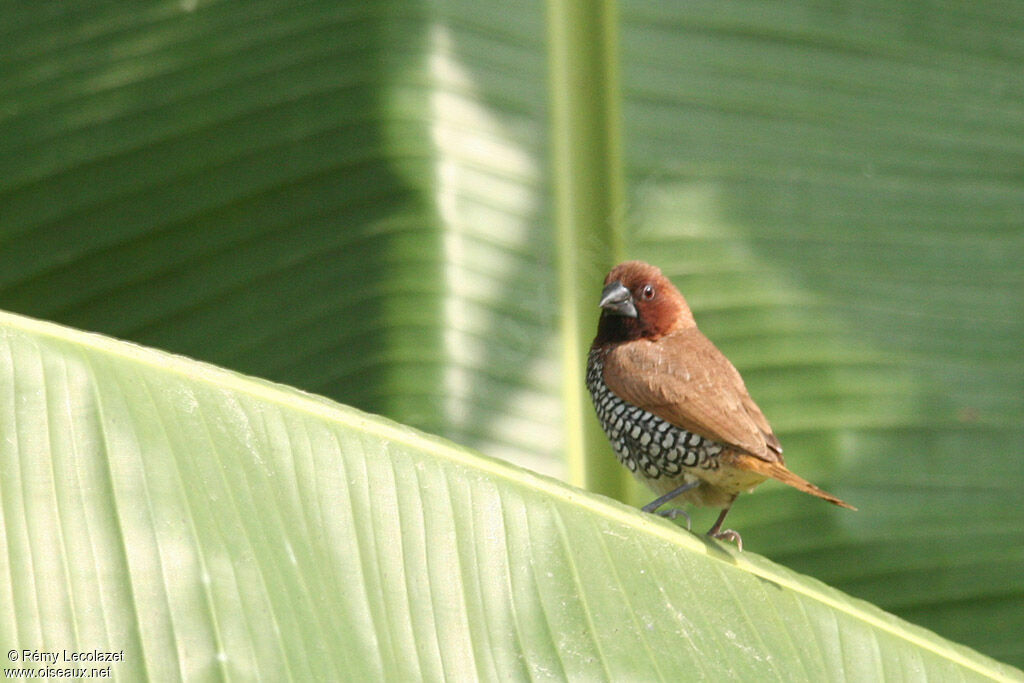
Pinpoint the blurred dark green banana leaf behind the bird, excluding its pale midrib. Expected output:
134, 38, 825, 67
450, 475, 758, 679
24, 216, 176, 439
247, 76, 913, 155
0, 0, 1024, 666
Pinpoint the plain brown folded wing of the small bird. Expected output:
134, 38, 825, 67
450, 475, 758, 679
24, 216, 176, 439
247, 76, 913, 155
604, 328, 782, 463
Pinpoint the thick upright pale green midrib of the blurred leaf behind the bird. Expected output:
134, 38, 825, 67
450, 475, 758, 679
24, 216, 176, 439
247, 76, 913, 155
548, 0, 626, 498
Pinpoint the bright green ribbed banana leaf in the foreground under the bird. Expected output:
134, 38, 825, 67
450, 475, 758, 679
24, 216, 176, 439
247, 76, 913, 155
0, 313, 1024, 681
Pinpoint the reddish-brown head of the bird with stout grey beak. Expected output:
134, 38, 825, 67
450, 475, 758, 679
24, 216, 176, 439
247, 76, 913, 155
594, 261, 696, 344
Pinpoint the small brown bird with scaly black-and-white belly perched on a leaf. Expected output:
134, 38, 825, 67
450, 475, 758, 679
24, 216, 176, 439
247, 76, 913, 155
587, 261, 856, 551
